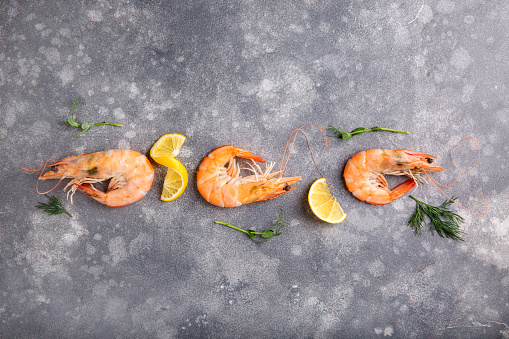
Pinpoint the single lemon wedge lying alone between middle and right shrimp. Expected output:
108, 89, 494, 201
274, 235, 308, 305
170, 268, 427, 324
308, 178, 346, 224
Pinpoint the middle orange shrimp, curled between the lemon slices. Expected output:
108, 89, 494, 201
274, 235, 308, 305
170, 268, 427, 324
196, 145, 300, 207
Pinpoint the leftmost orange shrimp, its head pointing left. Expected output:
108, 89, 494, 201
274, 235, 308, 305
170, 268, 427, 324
40, 149, 154, 207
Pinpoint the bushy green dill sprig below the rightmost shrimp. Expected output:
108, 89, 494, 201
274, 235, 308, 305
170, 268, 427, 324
408, 196, 464, 241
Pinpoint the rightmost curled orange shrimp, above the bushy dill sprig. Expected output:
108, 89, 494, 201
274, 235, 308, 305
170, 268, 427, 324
343, 149, 445, 205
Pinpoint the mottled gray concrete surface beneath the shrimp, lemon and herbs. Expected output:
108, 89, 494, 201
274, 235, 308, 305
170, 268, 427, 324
0, 0, 509, 338
